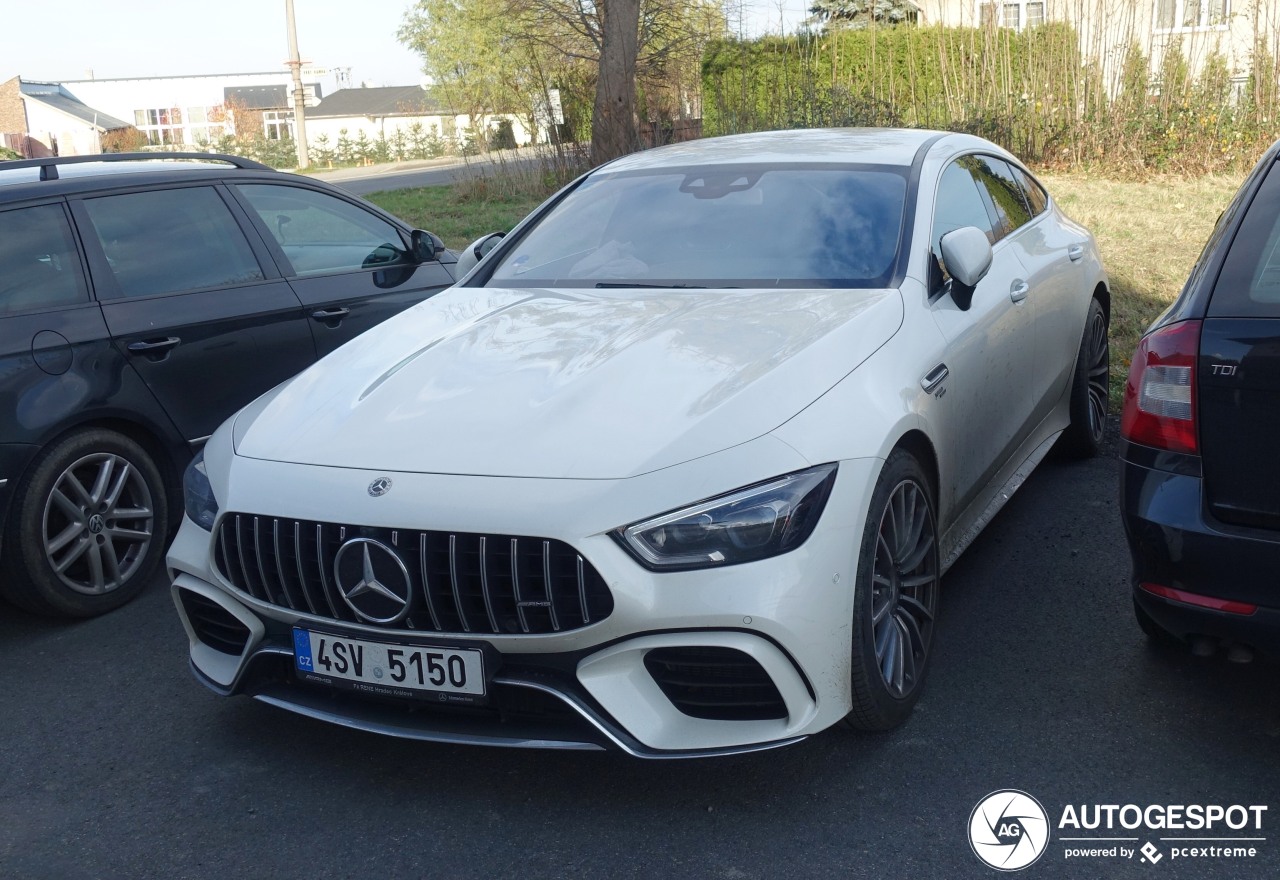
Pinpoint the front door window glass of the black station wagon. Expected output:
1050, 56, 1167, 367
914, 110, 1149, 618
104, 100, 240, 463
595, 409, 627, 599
237, 183, 412, 276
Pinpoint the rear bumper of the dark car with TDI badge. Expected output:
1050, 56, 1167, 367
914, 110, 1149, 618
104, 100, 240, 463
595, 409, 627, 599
1120, 444, 1280, 657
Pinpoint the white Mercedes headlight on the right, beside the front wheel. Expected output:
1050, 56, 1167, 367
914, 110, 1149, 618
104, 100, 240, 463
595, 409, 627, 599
612, 464, 836, 572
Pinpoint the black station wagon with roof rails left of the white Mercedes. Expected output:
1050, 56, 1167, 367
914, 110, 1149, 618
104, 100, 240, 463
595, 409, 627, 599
0, 153, 456, 617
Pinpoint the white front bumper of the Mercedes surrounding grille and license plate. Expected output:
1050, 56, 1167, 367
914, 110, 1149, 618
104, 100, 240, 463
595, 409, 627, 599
169, 459, 881, 757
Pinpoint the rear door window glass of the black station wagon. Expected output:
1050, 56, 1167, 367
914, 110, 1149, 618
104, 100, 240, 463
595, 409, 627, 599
84, 187, 262, 297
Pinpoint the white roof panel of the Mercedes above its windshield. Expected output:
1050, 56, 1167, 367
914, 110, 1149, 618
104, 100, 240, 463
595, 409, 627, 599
604, 128, 977, 171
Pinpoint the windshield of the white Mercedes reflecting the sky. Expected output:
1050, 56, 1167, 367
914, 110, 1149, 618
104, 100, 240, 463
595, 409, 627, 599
488, 165, 906, 288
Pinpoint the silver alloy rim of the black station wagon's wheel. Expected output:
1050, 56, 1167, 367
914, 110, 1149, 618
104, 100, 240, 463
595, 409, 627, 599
42, 453, 155, 596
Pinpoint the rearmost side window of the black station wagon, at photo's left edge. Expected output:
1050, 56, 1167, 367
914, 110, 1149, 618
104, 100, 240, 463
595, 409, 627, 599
0, 205, 88, 315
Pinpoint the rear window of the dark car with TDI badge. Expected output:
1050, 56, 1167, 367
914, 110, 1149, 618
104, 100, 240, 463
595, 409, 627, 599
1197, 160, 1280, 317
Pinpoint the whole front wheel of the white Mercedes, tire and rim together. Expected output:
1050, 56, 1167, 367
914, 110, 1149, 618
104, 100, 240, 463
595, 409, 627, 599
845, 449, 941, 730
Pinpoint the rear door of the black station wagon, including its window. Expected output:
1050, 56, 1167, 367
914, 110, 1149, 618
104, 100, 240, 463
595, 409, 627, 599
72, 185, 315, 441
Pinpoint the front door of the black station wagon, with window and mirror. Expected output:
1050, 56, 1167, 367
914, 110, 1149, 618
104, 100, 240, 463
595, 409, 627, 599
232, 183, 453, 357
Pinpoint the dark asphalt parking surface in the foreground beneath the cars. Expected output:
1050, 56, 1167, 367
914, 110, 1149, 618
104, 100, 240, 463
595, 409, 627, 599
0, 427, 1280, 880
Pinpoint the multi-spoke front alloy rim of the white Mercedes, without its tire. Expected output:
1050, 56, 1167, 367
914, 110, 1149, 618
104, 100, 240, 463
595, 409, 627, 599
872, 480, 940, 697
